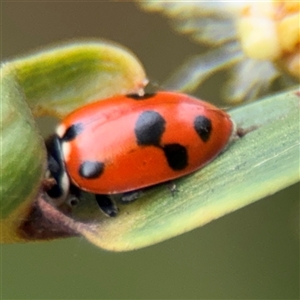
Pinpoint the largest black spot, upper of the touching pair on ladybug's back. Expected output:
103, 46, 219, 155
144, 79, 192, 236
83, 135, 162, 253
134, 110, 166, 146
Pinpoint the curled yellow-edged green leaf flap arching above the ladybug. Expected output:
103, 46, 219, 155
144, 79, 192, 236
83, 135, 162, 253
11, 40, 147, 118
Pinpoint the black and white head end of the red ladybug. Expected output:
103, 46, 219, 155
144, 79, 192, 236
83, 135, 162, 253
46, 135, 70, 205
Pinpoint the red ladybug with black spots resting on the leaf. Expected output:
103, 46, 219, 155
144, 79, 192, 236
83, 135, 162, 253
47, 92, 235, 216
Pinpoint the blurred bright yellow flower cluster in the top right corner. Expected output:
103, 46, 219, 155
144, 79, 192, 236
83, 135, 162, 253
237, 0, 300, 79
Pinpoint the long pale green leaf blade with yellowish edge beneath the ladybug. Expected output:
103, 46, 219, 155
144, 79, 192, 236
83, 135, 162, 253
65, 90, 300, 251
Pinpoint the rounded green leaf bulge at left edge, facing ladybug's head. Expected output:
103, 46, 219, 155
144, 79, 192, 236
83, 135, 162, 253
0, 65, 46, 242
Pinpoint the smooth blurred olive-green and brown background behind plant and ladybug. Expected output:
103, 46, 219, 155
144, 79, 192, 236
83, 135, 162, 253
0, 1, 300, 299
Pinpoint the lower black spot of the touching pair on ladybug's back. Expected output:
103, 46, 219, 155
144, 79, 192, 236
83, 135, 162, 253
162, 144, 188, 171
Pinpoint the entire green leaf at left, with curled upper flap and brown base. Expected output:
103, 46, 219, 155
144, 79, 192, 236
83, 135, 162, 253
0, 40, 147, 242
